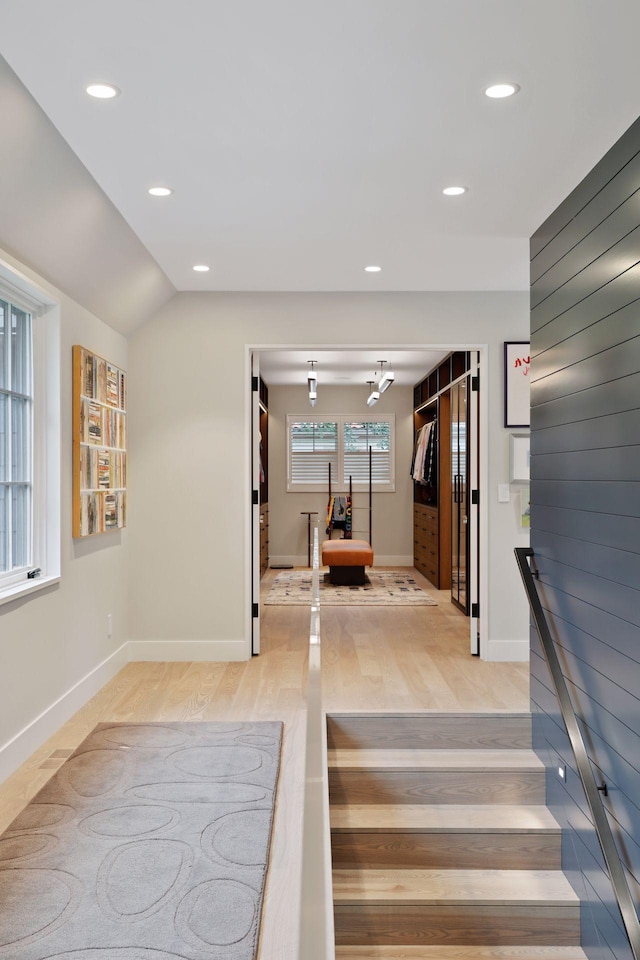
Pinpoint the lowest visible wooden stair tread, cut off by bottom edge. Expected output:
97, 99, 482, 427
336, 944, 587, 960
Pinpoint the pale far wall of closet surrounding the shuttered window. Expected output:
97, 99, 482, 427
269, 380, 412, 566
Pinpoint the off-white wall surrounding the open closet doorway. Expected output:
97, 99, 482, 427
129, 292, 529, 659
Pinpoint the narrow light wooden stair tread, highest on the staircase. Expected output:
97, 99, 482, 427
328, 749, 544, 772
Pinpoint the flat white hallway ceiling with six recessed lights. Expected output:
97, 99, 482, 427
0, 0, 640, 302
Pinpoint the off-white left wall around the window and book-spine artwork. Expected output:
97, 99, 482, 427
0, 251, 129, 779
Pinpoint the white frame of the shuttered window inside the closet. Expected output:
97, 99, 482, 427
287, 413, 396, 493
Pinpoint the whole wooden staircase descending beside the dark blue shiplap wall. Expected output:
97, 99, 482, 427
327, 714, 585, 960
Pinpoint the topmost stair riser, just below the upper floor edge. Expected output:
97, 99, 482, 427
327, 714, 531, 750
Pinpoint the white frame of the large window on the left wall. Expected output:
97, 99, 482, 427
0, 261, 61, 604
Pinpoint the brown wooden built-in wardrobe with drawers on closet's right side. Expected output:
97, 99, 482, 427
413, 351, 470, 590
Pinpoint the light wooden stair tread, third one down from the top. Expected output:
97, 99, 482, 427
333, 870, 579, 908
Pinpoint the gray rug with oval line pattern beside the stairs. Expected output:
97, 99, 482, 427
0, 721, 282, 960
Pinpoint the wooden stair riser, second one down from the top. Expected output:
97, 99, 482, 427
329, 768, 545, 804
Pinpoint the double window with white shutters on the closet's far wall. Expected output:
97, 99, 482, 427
287, 415, 395, 492
